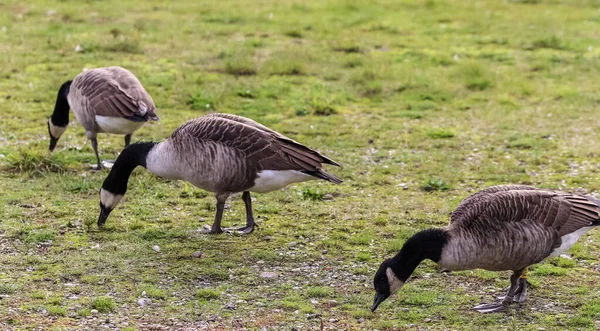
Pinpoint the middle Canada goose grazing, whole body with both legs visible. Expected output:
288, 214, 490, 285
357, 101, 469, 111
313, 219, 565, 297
98, 114, 342, 234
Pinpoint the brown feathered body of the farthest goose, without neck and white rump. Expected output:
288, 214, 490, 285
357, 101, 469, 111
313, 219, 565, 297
68, 67, 158, 132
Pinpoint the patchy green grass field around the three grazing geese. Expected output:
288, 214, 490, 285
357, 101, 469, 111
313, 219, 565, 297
0, 0, 600, 330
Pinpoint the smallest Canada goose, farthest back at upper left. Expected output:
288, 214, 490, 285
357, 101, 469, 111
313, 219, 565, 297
48, 67, 158, 169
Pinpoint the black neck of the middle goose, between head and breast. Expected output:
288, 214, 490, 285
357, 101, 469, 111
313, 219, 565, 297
102, 142, 156, 195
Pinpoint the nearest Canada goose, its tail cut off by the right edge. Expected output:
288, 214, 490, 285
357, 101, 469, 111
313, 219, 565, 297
371, 185, 600, 313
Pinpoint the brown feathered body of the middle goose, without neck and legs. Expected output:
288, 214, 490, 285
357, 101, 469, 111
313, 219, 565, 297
148, 114, 339, 192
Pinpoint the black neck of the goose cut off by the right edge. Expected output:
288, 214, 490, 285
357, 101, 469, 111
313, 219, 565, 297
390, 229, 448, 282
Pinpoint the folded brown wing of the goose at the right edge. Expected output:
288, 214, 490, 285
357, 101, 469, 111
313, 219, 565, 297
453, 190, 600, 236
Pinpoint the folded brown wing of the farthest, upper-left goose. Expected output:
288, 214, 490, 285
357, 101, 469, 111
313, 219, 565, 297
71, 67, 158, 121
